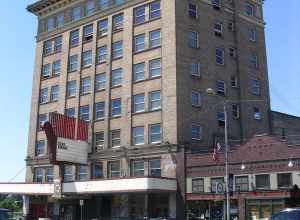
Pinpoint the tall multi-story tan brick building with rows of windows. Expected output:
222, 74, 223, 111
26, 0, 270, 219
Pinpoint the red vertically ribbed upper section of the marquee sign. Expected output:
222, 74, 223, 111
49, 112, 89, 141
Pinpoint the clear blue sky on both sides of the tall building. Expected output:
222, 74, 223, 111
0, 0, 300, 182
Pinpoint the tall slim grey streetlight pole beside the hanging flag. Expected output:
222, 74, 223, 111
223, 101, 230, 220
